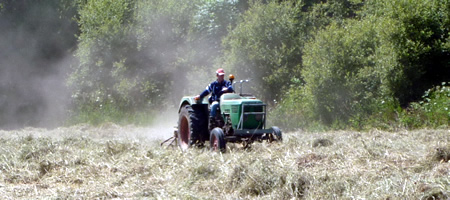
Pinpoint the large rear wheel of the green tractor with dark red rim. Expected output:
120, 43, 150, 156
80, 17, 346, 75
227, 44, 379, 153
177, 105, 205, 150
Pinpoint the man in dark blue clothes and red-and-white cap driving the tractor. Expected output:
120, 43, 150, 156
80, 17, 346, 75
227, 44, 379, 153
195, 68, 233, 126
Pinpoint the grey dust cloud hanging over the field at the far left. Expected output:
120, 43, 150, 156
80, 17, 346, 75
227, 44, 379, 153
0, 1, 77, 129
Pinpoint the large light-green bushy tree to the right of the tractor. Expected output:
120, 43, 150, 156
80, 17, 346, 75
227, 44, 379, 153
283, 0, 449, 129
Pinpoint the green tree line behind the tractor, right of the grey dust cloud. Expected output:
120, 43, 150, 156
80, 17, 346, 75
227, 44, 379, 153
0, 0, 450, 129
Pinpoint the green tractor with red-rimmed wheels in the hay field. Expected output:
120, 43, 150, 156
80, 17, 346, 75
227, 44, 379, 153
174, 75, 283, 152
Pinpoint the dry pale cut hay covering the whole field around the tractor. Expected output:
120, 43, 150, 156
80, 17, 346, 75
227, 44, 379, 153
0, 124, 450, 199
